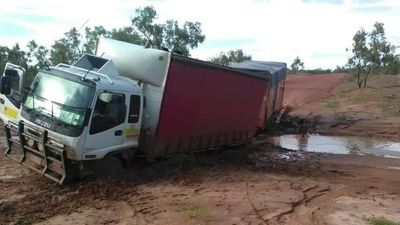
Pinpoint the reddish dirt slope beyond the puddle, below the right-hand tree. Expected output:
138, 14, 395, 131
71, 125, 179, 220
284, 74, 400, 139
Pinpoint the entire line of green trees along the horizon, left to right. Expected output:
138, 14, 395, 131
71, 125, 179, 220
0, 6, 400, 87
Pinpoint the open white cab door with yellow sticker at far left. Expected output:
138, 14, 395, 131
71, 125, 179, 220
0, 63, 25, 124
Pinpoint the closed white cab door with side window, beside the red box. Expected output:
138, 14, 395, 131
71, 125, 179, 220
84, 92, 127, 159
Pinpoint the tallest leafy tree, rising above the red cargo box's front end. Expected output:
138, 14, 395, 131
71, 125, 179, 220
132, 6, 205, 56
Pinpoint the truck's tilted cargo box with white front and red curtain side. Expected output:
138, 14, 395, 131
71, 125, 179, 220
97, 39, 266, 157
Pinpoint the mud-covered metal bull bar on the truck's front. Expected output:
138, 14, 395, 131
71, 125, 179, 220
4, 121, 70, 184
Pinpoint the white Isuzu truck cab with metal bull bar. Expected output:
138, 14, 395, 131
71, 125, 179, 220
1, 55, 143, 183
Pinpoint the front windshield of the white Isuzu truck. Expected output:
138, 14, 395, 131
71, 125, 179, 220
24, 72, 94, 126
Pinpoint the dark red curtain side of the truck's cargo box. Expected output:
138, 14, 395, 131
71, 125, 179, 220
146, 55, 267, 157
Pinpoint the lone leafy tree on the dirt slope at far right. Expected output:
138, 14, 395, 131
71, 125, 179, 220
348, 22, 400, 88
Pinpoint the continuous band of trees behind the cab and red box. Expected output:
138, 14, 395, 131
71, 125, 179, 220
0, 6, 206, 82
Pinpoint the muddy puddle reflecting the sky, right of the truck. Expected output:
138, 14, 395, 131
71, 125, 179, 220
268, 135, 400, 158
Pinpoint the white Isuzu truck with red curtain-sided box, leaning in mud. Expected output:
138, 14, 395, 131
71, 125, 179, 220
0, 38, 267, 184
